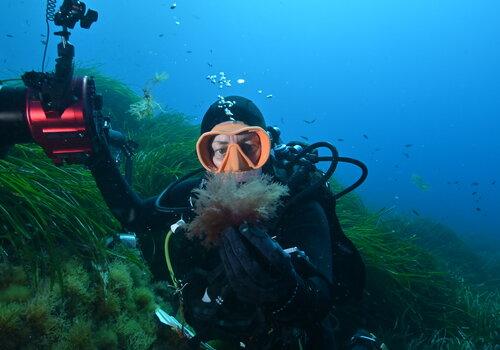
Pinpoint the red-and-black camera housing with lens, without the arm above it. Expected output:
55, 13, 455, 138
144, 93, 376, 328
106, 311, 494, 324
0, 77, 108, 165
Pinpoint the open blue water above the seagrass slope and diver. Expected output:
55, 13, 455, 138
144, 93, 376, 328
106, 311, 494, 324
0, 0, 500, 243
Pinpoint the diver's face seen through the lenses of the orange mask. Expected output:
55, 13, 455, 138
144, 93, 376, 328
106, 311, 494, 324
212, 132, 261, 168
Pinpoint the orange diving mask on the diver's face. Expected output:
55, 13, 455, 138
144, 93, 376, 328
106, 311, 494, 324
196, 121, 271, 173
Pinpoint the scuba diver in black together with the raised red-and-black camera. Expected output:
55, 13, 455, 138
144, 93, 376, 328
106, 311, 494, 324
0, 0, 380, 349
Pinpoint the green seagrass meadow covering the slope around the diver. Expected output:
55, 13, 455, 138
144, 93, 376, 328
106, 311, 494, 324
0, 68, 500, 349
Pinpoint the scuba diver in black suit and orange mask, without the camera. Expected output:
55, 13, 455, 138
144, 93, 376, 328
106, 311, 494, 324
89, 96, 378, 349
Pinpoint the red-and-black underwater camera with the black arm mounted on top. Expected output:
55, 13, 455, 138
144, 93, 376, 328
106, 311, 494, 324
0, 0, 110, 165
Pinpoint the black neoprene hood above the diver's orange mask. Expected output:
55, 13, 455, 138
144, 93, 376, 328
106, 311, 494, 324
200, 96, 266, 134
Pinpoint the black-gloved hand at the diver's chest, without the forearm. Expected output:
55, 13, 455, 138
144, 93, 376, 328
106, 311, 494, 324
219, 224, 300, 305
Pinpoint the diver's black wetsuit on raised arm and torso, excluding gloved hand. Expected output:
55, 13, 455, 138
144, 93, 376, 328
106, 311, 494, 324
90, 151, 362, 349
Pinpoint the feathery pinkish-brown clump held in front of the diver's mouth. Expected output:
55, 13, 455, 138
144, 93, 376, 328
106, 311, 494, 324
187, 174, 288, 246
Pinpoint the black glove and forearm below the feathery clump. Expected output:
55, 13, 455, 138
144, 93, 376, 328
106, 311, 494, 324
219, 224, 331, 323
